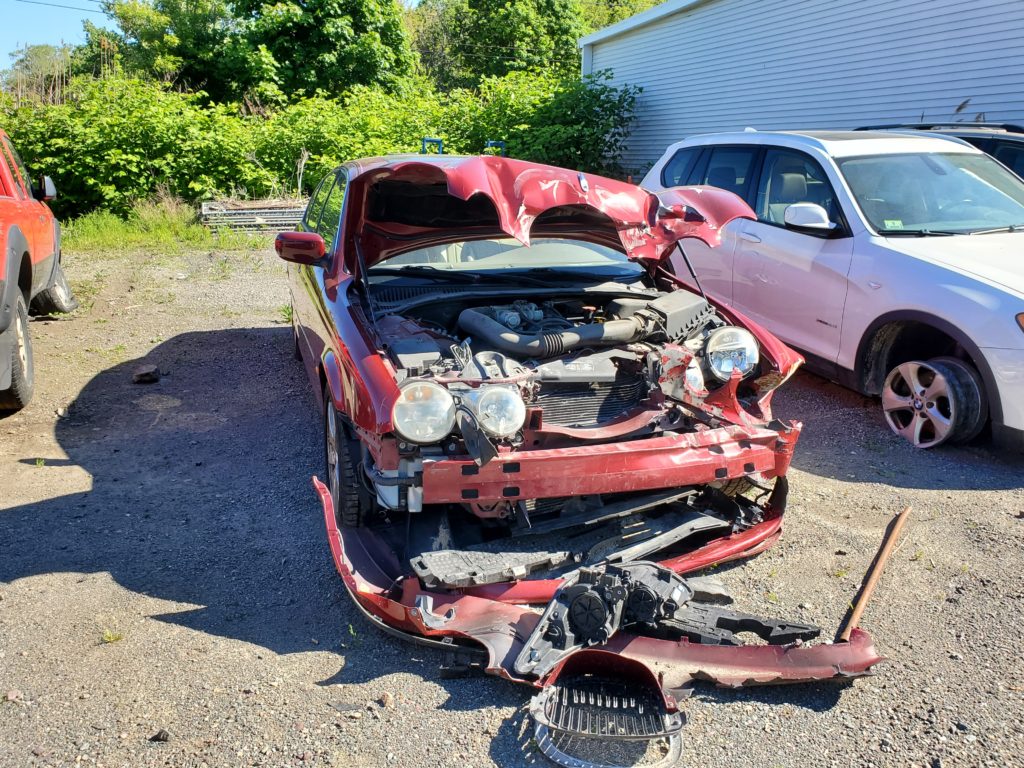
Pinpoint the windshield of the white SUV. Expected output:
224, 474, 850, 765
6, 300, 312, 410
837, 153, 1024, 234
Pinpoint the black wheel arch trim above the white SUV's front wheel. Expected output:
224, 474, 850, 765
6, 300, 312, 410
854, 309, 1002, 423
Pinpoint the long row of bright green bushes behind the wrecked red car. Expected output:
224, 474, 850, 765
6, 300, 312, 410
0, 72, 637, 217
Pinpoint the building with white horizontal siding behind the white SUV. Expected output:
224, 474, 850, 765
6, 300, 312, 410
580, 0, 1024, 172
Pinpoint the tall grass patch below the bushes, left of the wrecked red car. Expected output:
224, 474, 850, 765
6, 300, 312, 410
62, 194, 272, 254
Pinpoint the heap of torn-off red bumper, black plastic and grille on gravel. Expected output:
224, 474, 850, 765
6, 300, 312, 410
314, 478, 885, 768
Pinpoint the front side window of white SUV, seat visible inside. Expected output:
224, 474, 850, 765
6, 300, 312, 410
754, 150, 840, 224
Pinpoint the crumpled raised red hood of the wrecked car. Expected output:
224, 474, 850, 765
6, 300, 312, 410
342, 155, 755, 272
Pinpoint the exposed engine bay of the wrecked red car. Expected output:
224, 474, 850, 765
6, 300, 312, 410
377, 290, 763, 444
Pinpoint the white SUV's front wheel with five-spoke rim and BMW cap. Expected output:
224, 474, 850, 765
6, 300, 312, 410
882, 357, 988, 449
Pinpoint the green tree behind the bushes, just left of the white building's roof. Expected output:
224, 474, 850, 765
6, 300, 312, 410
455, 0, 585, 77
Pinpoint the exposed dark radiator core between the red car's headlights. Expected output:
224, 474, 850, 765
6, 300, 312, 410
537, 377, 647, 427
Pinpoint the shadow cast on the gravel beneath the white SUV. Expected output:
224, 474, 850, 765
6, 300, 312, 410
773, 372, 1024, 490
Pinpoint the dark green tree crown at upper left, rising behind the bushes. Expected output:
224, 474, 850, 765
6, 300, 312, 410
94, 0, 413, 103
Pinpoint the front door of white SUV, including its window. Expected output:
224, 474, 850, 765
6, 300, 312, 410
733, 147, 853, 361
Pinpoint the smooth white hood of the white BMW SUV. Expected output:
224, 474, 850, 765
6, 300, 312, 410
888, 232, 1024, 296
